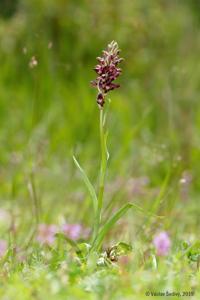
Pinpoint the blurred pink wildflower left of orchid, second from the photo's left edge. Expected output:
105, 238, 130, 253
36, 224, 57, 245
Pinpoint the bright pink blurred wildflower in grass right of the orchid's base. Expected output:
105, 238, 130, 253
153, 231, 171, 256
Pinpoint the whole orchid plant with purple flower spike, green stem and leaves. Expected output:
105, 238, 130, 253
73, 41, 153, 262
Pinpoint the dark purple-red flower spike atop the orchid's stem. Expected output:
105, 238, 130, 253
91, 41, 123, 108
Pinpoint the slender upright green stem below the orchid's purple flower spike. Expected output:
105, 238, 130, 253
93, 109, 107, 242
